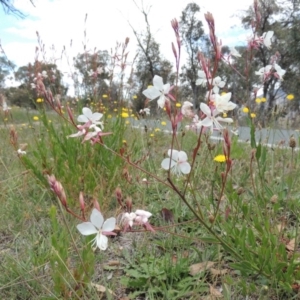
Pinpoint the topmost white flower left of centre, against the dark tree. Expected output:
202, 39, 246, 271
143, 75, 170, 108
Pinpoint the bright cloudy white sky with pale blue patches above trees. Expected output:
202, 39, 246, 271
0, 0, 253, 90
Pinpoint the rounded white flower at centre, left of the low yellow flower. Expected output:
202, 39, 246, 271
161, 149, 191, 175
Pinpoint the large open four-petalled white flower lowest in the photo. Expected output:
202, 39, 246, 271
76, 208, 116, 250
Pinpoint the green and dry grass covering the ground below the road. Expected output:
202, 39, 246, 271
0, 106, 300, 299
